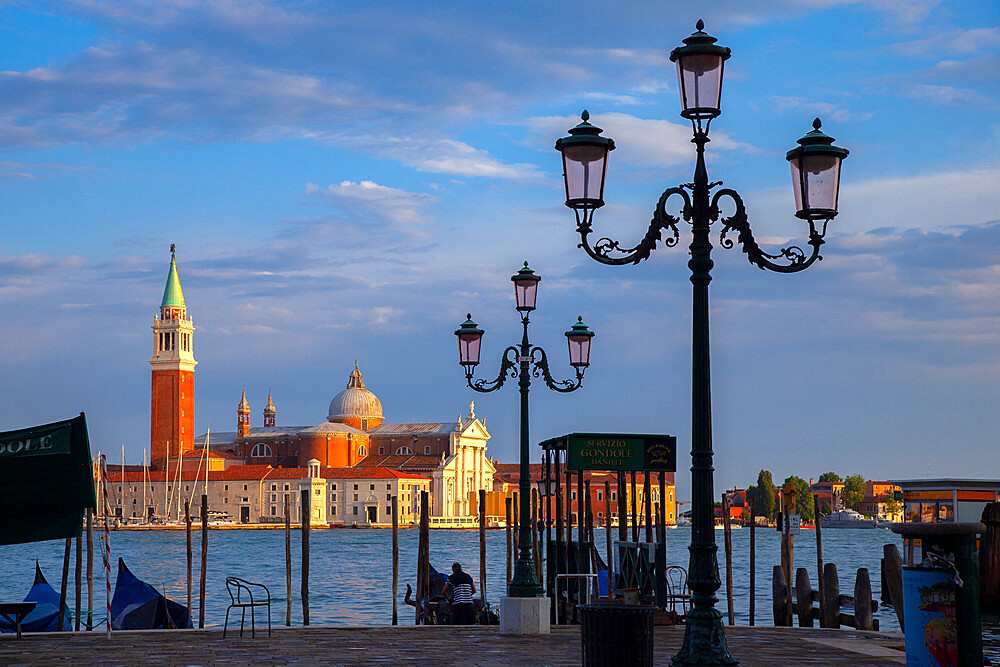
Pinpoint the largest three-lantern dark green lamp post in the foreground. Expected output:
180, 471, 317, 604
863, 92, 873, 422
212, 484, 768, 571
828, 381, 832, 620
556, 21, 848, 664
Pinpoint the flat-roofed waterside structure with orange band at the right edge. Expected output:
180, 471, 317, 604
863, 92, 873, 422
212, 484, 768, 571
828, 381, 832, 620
889, 478, 1000, 523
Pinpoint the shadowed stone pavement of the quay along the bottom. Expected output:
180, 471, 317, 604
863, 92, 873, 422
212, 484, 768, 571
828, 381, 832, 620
0, 626, 905, 667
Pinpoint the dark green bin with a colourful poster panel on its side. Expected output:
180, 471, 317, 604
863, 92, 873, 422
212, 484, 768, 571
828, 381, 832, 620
892, 522, 986, 665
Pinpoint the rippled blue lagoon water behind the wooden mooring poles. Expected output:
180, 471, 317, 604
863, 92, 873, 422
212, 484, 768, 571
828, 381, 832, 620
0, 528, 1000, 658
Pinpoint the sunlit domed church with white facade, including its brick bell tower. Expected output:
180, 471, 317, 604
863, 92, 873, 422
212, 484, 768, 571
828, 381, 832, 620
149, 246, 496, 517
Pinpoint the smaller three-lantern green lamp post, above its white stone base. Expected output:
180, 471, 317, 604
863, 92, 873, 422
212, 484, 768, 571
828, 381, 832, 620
455, 262, 594, 598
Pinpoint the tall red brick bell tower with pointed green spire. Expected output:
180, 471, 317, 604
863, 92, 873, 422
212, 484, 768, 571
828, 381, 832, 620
149, 244, 198, 468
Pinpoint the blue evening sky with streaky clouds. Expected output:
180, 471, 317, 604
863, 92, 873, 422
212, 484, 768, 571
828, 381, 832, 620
0, 0, 1000, 497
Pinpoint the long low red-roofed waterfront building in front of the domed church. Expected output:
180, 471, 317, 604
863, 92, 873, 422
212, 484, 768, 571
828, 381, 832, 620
108, 460, 431, 526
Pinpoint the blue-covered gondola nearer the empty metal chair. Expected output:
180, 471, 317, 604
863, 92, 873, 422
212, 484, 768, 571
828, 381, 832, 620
111, 558, 193, 630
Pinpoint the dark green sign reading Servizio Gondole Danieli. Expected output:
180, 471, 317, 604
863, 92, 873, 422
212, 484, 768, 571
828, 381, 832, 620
566, 433, 677, 472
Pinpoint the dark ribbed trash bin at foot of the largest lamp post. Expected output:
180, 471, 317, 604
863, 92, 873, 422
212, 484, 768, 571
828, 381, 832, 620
577, 604, 654, 667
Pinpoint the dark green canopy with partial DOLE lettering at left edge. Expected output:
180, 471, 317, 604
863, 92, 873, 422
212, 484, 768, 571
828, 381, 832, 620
0, 412, 95, 544
